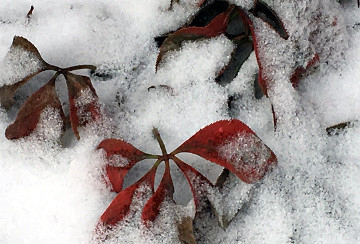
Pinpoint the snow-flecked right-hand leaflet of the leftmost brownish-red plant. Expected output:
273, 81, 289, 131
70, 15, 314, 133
64, 72, 101, 139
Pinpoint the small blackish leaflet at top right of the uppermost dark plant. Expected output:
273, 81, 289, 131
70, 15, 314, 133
252, 0, 289, 40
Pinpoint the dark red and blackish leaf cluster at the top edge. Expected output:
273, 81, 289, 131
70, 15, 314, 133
155, 0, 319, 126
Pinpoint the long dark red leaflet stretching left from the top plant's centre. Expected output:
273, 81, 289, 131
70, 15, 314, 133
155, 5, 235, 69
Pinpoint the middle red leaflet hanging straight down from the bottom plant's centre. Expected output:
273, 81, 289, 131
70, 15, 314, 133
141, 162, 174, 227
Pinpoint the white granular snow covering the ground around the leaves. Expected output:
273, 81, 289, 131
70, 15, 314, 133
0, 0, 360, 243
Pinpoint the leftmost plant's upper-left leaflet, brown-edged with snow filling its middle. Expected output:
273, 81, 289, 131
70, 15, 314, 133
0, 36, 54, 109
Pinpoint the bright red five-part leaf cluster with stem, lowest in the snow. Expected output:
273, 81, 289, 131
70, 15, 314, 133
97, 119, 277, 238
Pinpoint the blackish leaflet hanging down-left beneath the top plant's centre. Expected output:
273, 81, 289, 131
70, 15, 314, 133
216, 37, 253, 86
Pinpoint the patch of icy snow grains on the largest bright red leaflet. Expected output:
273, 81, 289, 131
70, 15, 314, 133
218, 132, 271, 182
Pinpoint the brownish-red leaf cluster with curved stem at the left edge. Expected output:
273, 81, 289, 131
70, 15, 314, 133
0, 36, 101, 139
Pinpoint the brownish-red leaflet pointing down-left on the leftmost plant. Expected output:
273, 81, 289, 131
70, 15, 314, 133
5, 75, 65, 139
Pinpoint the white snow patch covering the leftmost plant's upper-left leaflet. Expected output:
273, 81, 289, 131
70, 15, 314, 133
0, 47, 43, 86
